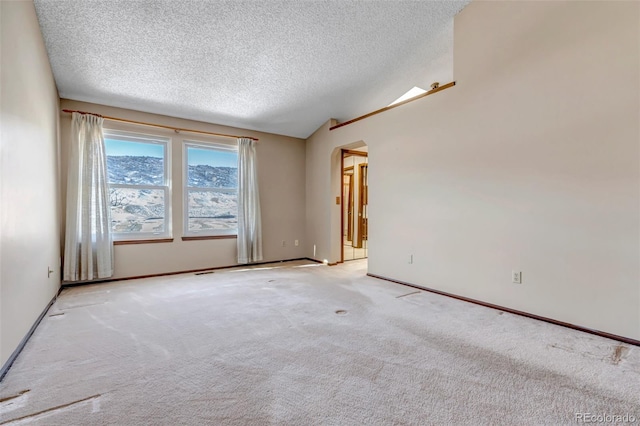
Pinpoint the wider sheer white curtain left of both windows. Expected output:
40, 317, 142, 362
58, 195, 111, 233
63, 113, 113, 281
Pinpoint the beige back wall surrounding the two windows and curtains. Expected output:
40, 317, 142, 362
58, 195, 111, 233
60, 99, 305, 278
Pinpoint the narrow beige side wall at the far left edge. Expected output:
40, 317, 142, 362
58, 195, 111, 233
0, 1, 60, 366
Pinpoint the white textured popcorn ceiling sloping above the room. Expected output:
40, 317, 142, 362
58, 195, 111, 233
34, 0, 468, 138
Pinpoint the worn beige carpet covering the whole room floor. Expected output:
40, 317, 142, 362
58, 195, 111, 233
0, 261, 640, 425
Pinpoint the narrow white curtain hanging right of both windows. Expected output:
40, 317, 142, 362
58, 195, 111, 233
238, 138, 262, 263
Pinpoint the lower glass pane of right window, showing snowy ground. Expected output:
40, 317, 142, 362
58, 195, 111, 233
187, 190, 238, 231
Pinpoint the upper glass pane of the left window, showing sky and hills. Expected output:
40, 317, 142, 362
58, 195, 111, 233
104, 138, 165, 185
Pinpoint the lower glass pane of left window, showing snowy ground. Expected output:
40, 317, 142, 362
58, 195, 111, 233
109, 188, 165, 232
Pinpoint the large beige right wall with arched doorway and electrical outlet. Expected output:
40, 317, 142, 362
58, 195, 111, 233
307, 2, 640, 339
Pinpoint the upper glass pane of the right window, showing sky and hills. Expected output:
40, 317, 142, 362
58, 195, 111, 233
187, 146, 238, 188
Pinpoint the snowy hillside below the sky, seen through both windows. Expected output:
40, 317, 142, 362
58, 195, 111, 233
107, 155, 238, 233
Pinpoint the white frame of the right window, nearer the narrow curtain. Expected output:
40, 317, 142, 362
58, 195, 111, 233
182, 139, 238, 240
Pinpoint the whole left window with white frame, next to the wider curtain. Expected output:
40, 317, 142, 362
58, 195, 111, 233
104, 130, 171, 241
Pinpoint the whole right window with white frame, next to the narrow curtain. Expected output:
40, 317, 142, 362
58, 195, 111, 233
184, 142, 238, 236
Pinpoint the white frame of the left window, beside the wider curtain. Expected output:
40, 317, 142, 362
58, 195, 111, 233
103, 128, 173, 244
